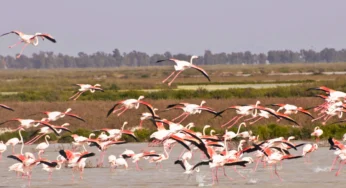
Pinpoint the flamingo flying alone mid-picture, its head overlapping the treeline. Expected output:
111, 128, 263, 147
156, 56, 210, 86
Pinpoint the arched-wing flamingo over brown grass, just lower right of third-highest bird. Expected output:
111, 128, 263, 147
107, 96, 155, 117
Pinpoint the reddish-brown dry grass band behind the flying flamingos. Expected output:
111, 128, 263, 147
0, 97, 324, 130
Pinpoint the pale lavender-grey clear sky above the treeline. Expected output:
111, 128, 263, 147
0, 0, 346, 56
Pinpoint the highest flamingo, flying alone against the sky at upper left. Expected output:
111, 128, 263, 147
0, 31, 56, 59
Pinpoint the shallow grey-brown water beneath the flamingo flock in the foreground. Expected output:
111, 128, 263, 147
0, 143, 346, 188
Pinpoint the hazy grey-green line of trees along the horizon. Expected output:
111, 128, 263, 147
0, 48, 346, 69
